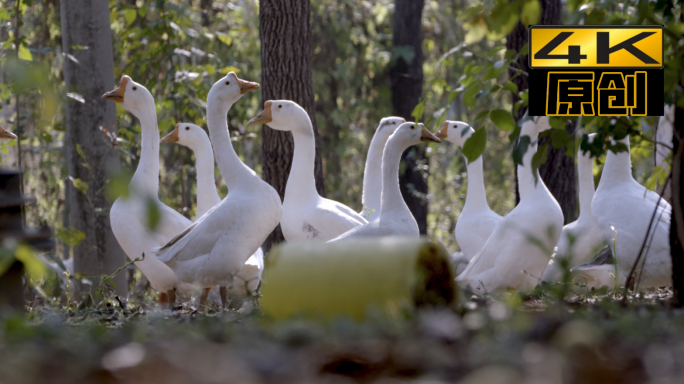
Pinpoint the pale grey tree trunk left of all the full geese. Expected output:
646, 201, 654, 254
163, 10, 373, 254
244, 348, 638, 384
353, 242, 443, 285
61, 0, 127, 295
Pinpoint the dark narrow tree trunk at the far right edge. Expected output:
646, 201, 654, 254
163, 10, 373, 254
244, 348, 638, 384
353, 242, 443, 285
670, 106, 684, 307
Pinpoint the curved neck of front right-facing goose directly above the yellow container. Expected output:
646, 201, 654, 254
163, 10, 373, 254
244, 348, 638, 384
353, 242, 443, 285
380, 139, 408, 215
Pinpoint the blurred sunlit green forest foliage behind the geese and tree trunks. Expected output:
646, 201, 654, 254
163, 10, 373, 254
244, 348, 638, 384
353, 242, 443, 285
0, 0, 672, 258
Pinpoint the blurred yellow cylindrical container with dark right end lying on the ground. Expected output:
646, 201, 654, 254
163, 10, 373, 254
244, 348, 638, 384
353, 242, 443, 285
261, 237, 457, 320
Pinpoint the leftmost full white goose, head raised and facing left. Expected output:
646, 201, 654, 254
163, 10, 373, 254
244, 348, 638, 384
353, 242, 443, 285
102, 76, 192, 307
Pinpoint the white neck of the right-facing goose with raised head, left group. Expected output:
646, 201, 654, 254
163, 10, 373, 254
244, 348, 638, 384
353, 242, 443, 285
207, 94, 254, 190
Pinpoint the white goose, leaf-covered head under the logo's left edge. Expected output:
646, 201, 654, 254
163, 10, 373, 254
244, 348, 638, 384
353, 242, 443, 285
456, 117, 563, 294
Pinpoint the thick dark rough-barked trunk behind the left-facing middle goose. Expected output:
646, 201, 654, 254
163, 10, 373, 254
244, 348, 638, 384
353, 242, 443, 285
259, 0, 325, 250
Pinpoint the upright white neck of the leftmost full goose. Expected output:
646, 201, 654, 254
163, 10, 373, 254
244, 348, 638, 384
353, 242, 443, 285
131, 107, 159, 197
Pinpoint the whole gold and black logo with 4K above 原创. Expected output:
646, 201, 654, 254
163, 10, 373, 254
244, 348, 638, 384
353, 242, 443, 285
528, 26, 664, 116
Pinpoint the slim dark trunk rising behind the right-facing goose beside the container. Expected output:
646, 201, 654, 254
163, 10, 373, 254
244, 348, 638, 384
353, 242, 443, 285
390, 0, 428, 235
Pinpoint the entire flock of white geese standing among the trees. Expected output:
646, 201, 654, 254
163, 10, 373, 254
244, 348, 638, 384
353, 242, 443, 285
5, 72, 672, 307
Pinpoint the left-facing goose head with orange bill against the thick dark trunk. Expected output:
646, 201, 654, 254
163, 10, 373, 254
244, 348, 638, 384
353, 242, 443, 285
247, 100, 311, 131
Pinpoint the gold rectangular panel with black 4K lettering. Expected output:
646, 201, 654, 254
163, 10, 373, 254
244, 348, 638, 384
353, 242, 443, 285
528, 26, 663, 69
